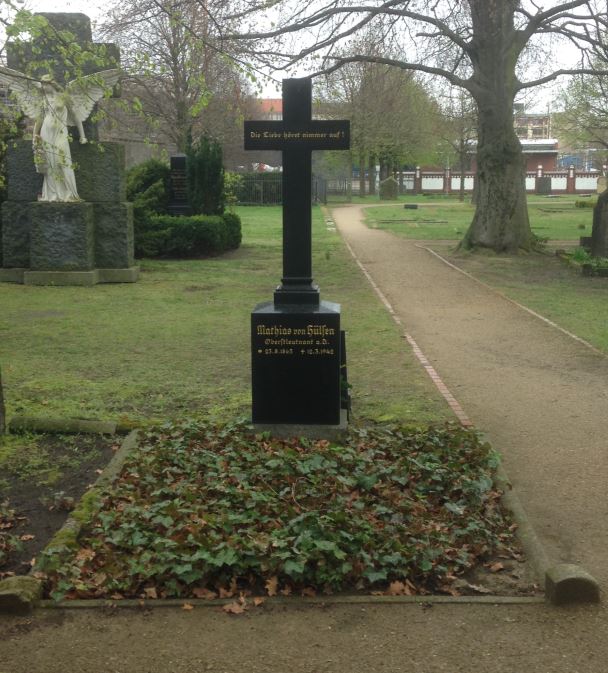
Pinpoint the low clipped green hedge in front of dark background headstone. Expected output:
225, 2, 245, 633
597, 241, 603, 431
136, 213, 241, 258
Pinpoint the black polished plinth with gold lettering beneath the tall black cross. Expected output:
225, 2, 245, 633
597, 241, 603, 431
251, 301, 341, 426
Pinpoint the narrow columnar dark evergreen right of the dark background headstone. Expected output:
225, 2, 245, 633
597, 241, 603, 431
186, 135, 226, 215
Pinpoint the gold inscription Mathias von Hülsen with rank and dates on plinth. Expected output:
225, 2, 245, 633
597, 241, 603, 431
256, 324, 336, 357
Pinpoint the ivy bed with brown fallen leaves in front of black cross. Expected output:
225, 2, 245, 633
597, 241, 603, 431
41, 423, 516, 599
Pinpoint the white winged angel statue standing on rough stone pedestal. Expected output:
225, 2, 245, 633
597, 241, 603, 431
0, 66, 120, 201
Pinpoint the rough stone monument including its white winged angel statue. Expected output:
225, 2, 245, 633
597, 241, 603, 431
0, 14, 138, 285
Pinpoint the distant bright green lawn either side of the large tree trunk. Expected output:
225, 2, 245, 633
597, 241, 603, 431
361, 196, 593, 241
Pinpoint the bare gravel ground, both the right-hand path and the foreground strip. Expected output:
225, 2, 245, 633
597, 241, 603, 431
0, 207, 608, 673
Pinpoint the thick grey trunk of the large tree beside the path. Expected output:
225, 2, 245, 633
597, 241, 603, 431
461, 0, 533, 252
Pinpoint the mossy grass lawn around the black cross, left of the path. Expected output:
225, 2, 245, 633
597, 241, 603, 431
0, 207, 448, 430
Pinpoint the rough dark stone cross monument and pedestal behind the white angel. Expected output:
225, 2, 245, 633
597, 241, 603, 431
0, 13, 139, 285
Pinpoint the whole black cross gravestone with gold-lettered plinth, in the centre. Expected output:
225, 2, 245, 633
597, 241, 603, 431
245, 78, 350, 431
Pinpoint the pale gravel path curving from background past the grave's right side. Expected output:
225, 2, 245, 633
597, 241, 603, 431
333, 206, 608, 586
